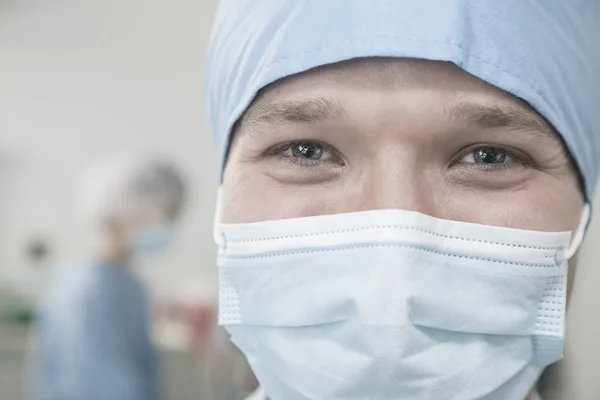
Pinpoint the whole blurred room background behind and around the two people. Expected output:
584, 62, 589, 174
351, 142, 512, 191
0, 0, 600, 400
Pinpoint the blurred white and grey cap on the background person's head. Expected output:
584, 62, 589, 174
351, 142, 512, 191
76, 157, 186, 226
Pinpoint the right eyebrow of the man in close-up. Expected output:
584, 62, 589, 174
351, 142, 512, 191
449, 102, 562, 143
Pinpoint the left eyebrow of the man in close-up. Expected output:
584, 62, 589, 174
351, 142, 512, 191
244, 97, 347, 126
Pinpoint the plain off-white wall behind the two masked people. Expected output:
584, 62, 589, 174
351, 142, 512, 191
0, 0, 600, 394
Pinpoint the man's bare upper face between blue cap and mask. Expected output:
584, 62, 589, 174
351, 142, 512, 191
221, 58, 583, 248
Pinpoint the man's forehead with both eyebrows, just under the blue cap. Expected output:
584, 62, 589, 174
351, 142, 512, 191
239, 57, 564, 150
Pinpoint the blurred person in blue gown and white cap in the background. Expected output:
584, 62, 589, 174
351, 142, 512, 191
33, 158, 186, 400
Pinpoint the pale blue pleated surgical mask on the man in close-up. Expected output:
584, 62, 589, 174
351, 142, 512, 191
215, 206, 589, 400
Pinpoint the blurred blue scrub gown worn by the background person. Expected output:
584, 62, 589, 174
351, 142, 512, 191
33, 262, 159, 400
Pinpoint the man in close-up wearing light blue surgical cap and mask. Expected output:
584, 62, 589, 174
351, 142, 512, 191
206, 0, 600, 400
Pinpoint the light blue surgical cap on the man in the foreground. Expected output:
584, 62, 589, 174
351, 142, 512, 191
206, 0, 600, 200
